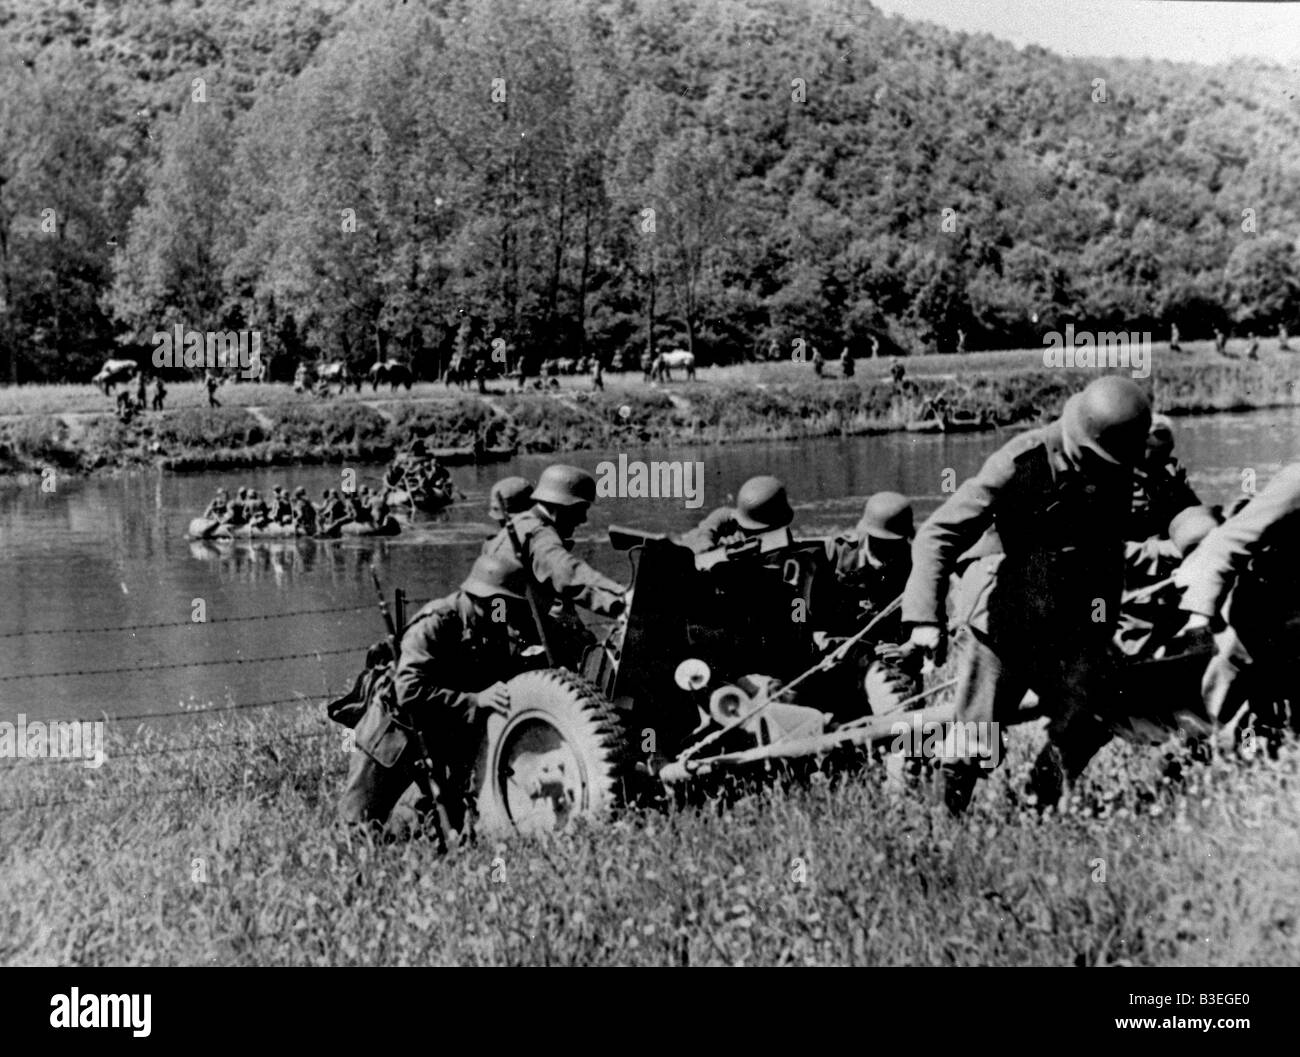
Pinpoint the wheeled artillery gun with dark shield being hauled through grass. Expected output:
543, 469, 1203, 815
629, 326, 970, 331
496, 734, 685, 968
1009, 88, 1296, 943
476, 528, 950, 832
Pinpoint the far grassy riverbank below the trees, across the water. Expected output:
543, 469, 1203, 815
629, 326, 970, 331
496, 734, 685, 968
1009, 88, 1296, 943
0, 346, 1300, 477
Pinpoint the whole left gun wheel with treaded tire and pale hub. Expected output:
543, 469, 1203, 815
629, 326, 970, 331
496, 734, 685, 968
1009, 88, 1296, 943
478, 670, 628, 833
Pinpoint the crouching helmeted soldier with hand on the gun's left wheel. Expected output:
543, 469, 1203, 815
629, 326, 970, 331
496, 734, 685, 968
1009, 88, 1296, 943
339, 555, 533, 841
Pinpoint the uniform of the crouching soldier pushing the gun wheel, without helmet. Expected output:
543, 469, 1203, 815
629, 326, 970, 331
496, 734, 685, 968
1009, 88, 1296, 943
339, 590, 524, 835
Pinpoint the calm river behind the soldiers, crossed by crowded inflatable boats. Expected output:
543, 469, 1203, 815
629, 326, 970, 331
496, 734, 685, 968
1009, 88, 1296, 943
0, 408, 1300, 723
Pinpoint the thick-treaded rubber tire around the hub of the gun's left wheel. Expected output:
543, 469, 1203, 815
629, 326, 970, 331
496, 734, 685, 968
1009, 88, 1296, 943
477, 668, 632, 833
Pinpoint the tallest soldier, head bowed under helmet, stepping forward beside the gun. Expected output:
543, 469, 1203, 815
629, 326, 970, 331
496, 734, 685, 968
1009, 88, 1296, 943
902, 376, 1151, 814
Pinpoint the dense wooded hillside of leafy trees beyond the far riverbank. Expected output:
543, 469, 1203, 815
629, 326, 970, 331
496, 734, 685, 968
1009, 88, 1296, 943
0, 0, 1300, 381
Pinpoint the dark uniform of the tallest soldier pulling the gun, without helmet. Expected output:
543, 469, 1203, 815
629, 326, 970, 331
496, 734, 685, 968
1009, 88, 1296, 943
902, 421, 1132, 800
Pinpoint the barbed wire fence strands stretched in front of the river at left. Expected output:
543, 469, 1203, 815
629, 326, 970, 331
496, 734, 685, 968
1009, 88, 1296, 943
0, 598, 444, 814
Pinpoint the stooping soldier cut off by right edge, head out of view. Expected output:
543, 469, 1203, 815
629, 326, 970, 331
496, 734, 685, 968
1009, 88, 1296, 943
1174, 463, 1300, 743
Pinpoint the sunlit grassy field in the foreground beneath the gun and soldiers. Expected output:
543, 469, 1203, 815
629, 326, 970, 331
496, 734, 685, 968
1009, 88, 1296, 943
0, 707, 1300, 966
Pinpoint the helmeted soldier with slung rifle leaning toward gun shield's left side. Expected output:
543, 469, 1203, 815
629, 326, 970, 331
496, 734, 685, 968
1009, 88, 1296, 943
484, 464, 628, 668
